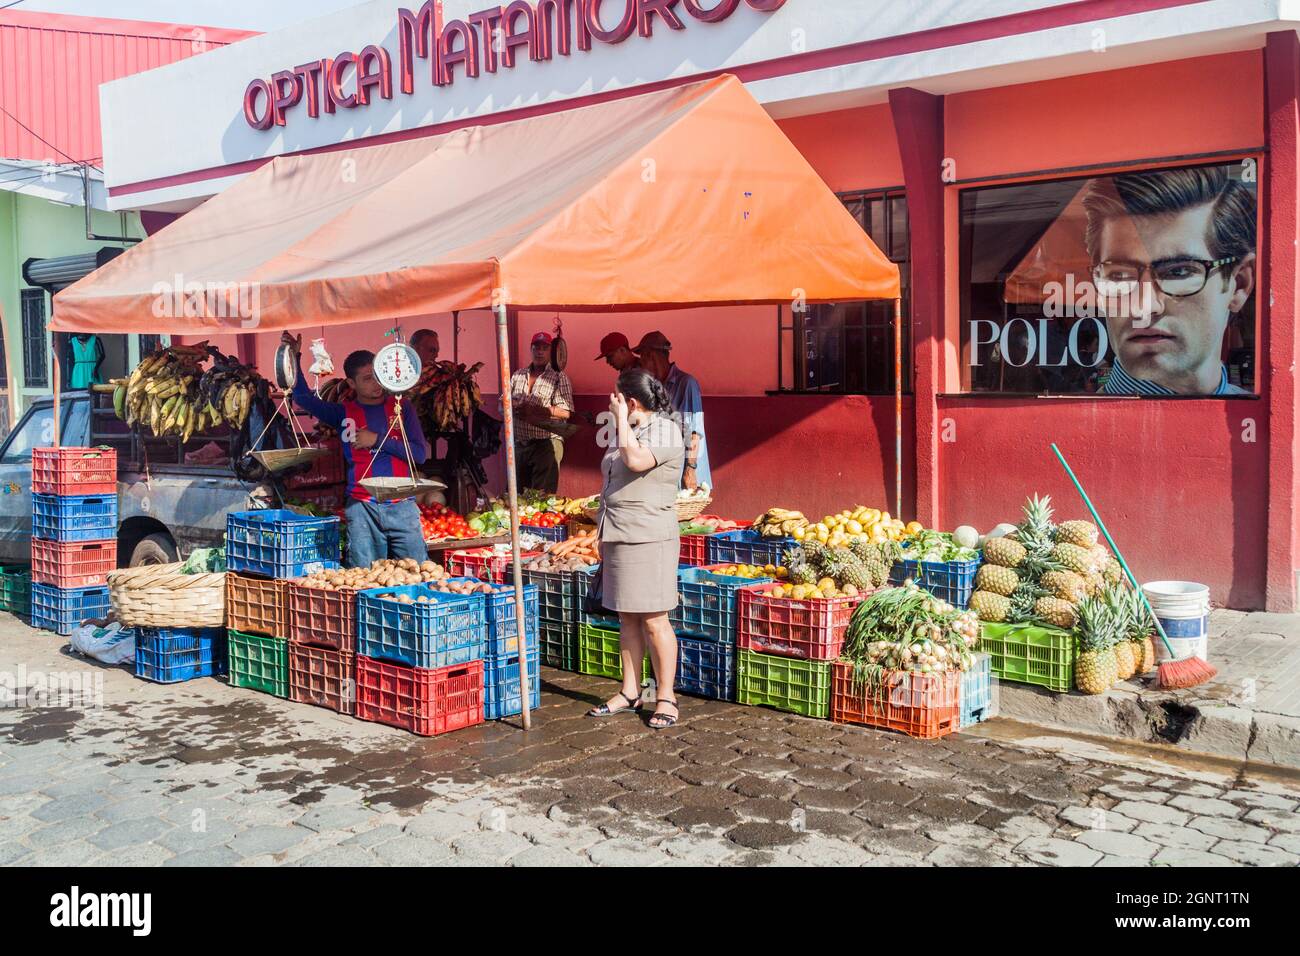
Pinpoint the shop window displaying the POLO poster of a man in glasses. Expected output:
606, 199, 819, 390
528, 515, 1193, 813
959, 159, 1257, 397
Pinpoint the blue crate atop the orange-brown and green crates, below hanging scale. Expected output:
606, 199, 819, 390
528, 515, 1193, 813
226, 509, 339, 578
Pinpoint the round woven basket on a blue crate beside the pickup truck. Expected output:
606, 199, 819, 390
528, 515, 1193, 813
108, 562, 226, 627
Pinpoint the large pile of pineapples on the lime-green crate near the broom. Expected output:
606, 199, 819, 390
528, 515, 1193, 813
970, 496, 1121, 630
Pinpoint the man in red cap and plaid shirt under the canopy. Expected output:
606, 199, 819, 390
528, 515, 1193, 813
510, 332, 573, 494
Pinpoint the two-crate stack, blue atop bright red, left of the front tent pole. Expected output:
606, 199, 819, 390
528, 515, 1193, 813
356, 584, 488, 736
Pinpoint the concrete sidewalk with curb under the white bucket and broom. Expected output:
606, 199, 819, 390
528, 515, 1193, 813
996, 610, 1300, 767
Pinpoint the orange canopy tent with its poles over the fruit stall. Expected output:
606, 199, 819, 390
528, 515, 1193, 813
49, 75, 902, 727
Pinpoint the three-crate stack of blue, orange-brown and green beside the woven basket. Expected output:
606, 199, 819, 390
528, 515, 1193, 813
226, 509, 346, 713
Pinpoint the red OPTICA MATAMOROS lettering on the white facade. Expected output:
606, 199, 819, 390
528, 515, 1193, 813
243, 0, 785, 130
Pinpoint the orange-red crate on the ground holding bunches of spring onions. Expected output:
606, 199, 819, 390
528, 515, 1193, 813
831, 661, 962, 740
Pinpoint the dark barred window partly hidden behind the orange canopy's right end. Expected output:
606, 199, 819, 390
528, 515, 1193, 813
777, 191, 911, 395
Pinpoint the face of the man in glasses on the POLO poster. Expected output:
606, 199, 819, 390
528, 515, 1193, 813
1097, 203, 1255, 394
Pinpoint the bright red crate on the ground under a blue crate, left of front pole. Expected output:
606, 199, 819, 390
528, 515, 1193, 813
356, 657, 484, 737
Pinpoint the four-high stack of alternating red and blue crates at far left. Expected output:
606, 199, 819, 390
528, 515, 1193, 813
31, 447, 117, 635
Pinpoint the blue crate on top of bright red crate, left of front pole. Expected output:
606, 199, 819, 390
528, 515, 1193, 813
356, 584, 488, 669
